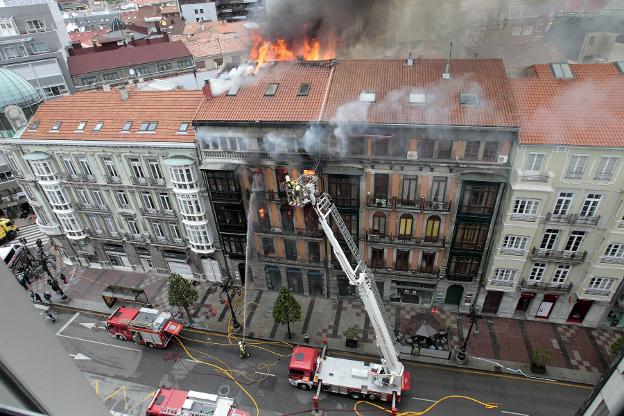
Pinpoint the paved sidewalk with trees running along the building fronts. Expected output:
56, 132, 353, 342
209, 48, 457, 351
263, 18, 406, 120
25, 262, 622, 384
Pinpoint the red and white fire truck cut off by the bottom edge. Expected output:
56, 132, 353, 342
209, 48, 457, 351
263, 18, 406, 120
146, 387, 249, 416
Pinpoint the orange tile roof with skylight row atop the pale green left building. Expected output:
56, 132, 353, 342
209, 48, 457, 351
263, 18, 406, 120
21, 90, 203, 143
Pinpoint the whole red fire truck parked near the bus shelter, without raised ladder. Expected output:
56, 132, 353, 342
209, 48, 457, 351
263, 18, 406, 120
106, 306, 184, 348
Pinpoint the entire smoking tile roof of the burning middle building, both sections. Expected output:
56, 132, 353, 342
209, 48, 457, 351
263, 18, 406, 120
198, 59, 518, 127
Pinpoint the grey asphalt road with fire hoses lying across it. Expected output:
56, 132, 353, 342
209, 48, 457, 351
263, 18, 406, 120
50, 310, 590, 416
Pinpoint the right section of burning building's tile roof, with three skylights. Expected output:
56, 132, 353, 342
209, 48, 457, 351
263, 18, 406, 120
323, 59, 518, 127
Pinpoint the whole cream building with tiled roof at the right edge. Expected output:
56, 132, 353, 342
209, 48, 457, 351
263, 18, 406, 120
480, 64, 624, 327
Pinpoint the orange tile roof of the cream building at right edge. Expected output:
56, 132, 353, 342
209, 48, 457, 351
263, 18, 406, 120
511, 64, 624, 147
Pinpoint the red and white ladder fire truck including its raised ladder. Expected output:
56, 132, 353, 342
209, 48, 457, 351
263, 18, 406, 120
285, 174, 410, 411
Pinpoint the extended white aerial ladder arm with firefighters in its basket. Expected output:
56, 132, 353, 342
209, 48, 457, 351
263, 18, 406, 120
284, 174, 404, 400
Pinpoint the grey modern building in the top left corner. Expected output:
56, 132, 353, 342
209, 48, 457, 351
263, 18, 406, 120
0, 0, 74, 99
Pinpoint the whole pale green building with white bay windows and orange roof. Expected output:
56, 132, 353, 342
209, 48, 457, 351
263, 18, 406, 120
2, 90, 222, 281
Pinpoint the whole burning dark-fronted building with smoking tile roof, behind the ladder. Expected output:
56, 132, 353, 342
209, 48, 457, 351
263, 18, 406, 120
194, 60, 517, 307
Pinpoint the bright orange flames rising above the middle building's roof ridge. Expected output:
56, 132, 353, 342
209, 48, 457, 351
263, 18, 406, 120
249, 31, 338, 68
